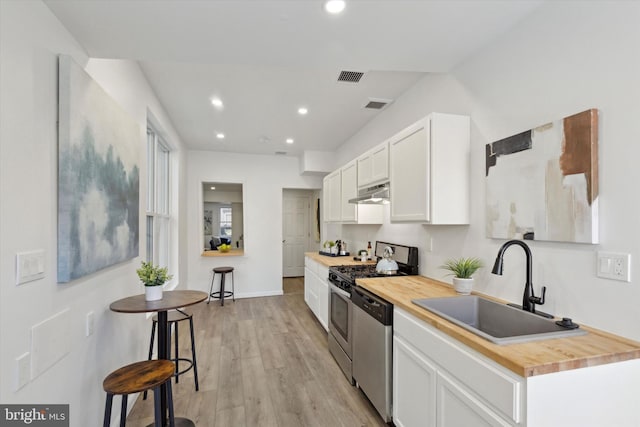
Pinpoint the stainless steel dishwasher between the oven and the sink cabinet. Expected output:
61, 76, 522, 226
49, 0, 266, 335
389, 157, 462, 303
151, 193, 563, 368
351, 286, 393, 423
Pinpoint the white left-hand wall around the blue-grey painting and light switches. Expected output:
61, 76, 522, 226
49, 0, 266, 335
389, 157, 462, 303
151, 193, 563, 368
0, 1, 186, 427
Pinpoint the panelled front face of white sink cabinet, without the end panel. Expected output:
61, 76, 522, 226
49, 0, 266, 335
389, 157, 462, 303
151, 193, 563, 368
393, 308, 524, 427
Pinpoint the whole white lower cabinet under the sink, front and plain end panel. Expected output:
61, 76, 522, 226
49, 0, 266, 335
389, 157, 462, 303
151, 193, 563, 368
393, 307, 640, 427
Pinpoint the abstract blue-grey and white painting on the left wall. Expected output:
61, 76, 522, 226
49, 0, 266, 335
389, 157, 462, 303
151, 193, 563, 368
58, 55, 140, 283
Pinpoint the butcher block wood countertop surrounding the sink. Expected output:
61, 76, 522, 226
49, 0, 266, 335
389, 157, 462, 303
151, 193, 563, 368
356, 276, 640, 377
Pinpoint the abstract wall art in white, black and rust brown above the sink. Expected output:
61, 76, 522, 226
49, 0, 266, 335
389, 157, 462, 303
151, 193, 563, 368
485, 109, 598, 244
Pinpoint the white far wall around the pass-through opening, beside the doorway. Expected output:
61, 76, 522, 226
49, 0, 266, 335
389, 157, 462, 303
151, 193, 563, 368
186, 151, 322, 298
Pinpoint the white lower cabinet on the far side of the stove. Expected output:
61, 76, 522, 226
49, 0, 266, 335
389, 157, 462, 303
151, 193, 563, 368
304, 257, 329, 330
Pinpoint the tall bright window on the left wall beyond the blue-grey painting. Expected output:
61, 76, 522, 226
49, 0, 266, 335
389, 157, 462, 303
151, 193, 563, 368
147, 126, 171, 270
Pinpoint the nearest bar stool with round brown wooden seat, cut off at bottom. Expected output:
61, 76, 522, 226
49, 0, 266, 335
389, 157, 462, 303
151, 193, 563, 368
102, 359, 175, 427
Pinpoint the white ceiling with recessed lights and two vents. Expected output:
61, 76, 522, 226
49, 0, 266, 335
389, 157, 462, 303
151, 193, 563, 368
44, 0, 542, 155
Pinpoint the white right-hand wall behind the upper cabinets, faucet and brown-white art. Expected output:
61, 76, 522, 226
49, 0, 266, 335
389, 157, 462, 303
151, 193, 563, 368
327, 1, 640, 340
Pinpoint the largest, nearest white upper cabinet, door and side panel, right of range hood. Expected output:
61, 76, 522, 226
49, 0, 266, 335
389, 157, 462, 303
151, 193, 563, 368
389, 113, 470, 224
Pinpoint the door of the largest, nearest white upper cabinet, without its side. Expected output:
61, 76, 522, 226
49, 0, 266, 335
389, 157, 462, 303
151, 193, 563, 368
389, 119, 430, 222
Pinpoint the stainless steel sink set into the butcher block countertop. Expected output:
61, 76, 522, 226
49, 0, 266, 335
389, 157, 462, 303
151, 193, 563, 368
412, 295, 587, 345
